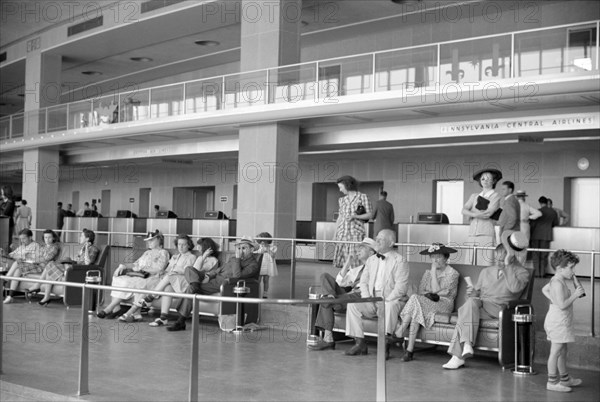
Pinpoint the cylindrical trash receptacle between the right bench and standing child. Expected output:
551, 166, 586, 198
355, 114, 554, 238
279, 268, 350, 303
513, 305, 536, 375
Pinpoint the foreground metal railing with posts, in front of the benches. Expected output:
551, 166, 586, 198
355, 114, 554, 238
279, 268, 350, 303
0, 275, 387, 402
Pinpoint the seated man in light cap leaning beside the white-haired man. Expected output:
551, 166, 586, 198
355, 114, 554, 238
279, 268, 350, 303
308, 237, 377, 350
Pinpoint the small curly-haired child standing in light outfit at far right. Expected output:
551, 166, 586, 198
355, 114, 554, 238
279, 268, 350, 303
542, 250, 584, 392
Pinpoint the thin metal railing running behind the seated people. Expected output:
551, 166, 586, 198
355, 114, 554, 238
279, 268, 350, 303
22, 229, 600, 336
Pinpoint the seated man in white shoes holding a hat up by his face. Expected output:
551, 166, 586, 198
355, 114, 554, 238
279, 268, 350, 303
443, 231, 529, 370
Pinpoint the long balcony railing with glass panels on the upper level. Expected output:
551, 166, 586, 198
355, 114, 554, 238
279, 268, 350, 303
0, 20, 600, 140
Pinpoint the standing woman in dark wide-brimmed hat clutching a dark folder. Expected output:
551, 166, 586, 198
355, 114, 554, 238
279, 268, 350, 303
462, 169, 502, 265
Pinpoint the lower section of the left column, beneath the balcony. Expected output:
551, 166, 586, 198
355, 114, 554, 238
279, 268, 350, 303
23, 148, 60, 238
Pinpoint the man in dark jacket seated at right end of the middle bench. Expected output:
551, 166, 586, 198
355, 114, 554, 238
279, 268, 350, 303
167, 237, 260, 331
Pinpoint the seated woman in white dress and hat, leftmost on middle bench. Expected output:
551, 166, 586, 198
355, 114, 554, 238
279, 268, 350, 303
96, 230, 169, 318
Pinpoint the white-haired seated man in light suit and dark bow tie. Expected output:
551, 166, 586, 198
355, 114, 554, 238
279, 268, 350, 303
346, 229, 408, 356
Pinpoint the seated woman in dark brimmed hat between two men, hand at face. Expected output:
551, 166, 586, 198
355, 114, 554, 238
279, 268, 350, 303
396, 243, 459, 362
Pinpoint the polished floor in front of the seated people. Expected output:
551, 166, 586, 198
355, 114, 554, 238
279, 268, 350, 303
0, 294, 600, 401
